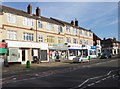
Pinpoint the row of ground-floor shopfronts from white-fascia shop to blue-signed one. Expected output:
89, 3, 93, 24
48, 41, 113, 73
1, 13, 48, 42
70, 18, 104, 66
0, 40, 100, 64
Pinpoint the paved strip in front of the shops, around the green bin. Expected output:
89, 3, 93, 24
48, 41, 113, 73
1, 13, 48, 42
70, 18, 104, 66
2, 59, 98, 74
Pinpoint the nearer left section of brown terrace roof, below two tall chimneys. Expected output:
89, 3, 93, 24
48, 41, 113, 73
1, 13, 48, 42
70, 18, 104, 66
0, 5, 63, 25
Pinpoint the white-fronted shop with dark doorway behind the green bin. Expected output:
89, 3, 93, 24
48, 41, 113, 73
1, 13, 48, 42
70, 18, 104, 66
6, 40, 41, 64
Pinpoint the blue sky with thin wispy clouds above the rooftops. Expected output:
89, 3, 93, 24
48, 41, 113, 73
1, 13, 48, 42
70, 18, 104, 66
2, 2, 118, 40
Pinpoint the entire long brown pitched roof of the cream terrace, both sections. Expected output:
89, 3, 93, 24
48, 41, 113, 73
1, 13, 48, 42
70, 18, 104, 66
0, 5, 92, 32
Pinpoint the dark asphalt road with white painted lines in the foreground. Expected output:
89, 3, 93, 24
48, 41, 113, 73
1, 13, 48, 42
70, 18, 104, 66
2, 58, 120, 89
